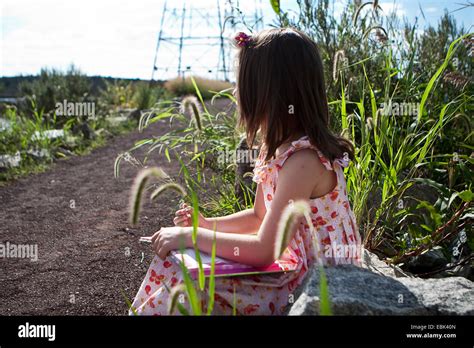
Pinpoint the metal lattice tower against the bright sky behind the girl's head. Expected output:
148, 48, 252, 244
151, 0, 263, 81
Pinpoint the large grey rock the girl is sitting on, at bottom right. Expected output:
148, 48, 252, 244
289, 251, 474, 315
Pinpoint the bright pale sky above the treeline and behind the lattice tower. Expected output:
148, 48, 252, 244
0, 0, 474, 79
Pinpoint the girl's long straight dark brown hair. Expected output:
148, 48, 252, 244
236, 28, 354, 160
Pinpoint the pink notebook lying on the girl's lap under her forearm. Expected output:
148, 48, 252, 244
170, 249, 297, 279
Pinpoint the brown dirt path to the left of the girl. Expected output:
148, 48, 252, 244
0, 119, 182, 315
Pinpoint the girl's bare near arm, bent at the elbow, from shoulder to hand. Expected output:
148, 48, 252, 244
153, 150, 326, 267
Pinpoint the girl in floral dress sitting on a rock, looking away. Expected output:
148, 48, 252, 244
132, 28, 360, 315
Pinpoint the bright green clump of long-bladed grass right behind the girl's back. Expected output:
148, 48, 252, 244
333, 36, 469, 260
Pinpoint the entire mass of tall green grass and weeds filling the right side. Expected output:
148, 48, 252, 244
277, 0, 474, 262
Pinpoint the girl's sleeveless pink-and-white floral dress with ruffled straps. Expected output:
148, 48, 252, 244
129, 137, 361, 315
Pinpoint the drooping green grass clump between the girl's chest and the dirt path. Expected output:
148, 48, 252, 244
115, 78, 250, 216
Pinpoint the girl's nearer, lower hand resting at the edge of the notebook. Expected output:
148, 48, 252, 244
151, 227, 191, 260
